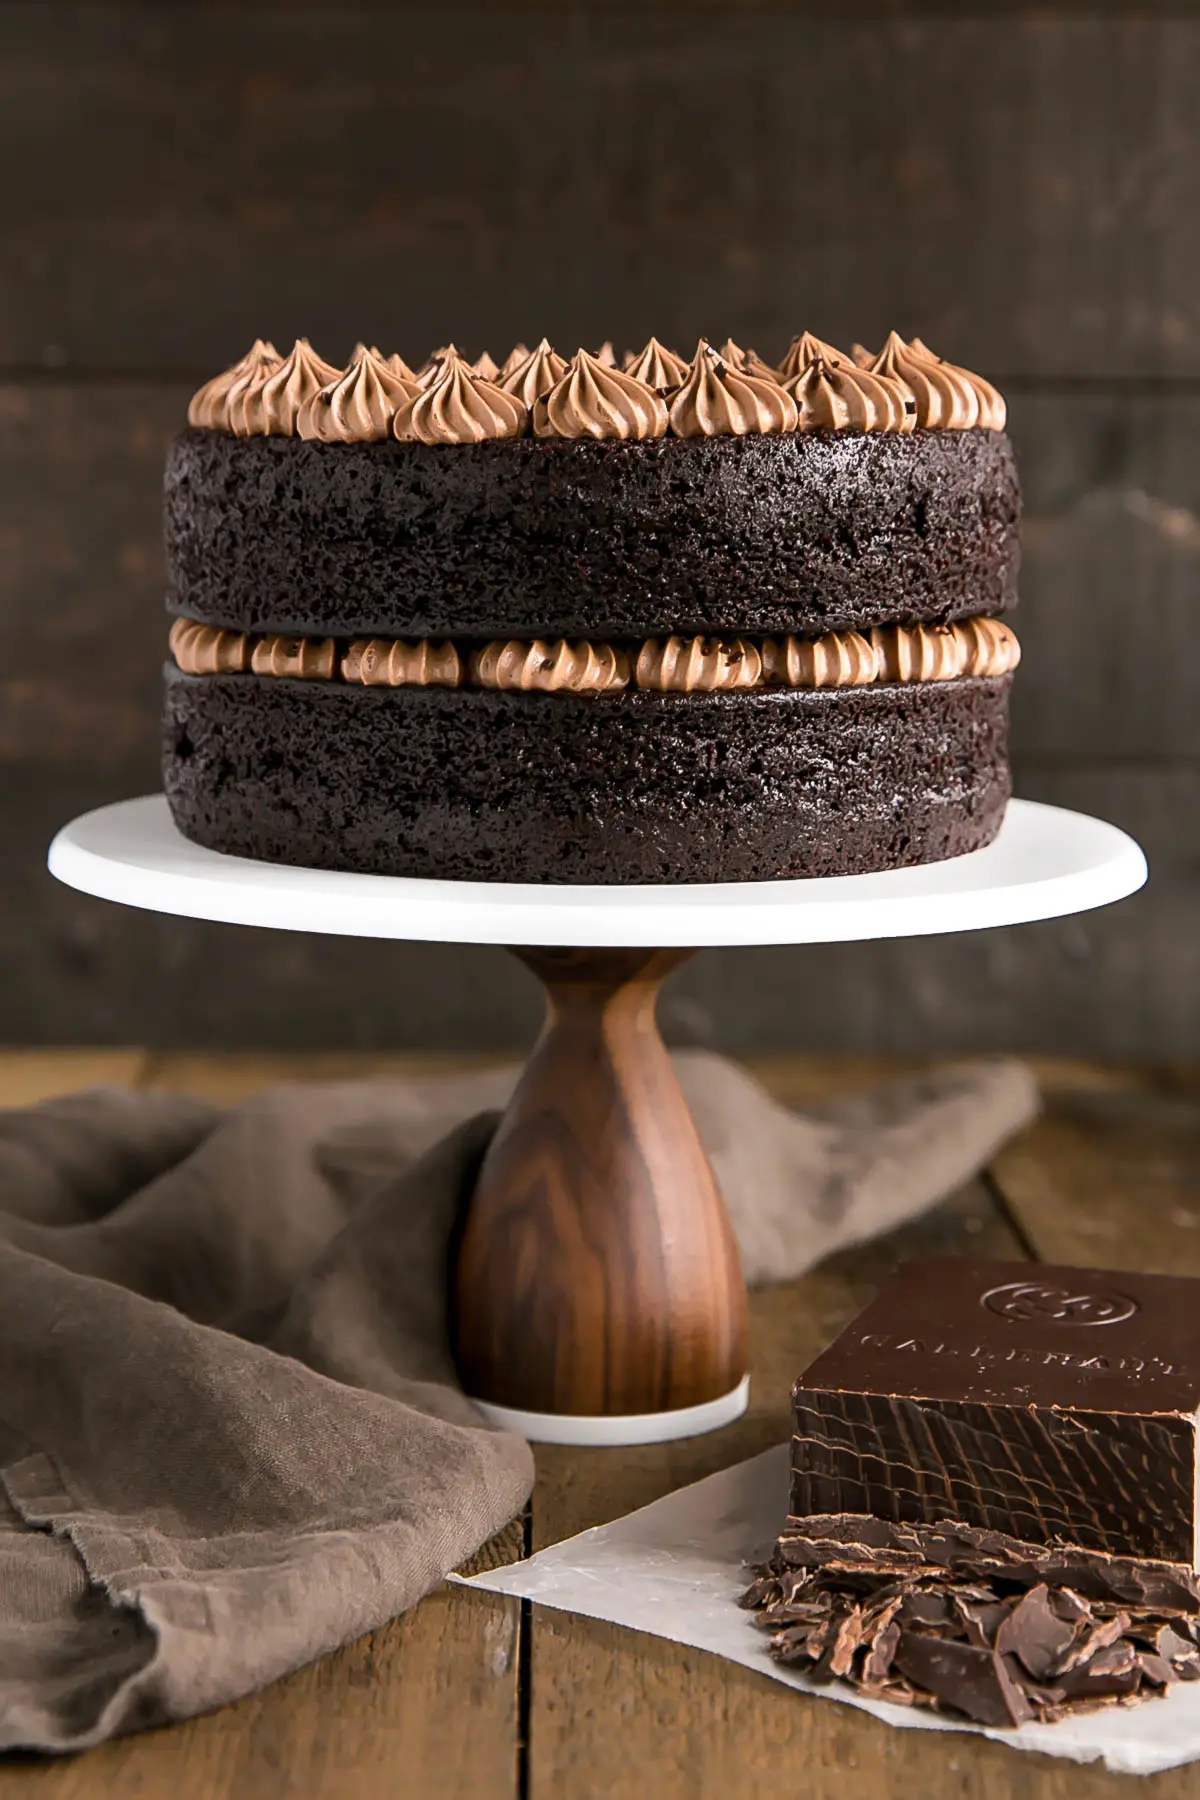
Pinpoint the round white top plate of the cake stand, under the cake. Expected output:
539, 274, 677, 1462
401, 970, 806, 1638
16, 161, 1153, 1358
49, 794, 1146, 950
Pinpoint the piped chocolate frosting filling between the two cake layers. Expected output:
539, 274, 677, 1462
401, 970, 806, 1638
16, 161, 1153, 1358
171, 619, 1020, 695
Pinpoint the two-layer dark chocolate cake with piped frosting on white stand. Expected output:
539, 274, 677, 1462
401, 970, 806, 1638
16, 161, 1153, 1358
166, 335, 1020, 882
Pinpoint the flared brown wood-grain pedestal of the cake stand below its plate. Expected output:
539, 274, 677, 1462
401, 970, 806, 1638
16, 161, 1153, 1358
457, 949, 747, 1442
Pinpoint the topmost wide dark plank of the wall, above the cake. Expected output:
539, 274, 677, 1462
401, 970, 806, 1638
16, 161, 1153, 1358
0, 4, 1200, 378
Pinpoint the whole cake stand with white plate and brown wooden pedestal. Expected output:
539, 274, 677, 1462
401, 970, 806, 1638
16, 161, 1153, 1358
49, 794, 1146, 1444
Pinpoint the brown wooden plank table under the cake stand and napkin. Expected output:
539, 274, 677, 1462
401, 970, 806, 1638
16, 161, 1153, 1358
0, 1049, 1200, 1800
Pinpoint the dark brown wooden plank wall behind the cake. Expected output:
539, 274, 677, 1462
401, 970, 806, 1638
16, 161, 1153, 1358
0, 0, 1200, 1057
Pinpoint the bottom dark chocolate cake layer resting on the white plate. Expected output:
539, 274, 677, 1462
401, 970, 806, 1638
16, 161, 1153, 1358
164, 666, 1011, 884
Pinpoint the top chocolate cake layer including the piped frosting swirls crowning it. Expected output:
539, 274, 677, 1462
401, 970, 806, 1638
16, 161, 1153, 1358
166, 335, 1020, 639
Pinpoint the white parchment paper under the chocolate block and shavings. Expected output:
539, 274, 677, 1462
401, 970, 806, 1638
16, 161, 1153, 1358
452, 1444, 1200, 1775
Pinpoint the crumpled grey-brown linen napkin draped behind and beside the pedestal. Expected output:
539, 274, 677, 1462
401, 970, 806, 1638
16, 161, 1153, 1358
0, 1051, 1036, 1750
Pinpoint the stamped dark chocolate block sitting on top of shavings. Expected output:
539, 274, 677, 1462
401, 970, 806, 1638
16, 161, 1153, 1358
792, 1256, 1200, 1568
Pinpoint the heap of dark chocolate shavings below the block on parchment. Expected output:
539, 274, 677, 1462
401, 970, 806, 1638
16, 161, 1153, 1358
741, 1516, 1200, 1728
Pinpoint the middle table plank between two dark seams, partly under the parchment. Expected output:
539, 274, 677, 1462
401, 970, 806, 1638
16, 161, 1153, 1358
531, 1173, 1027, 1800
